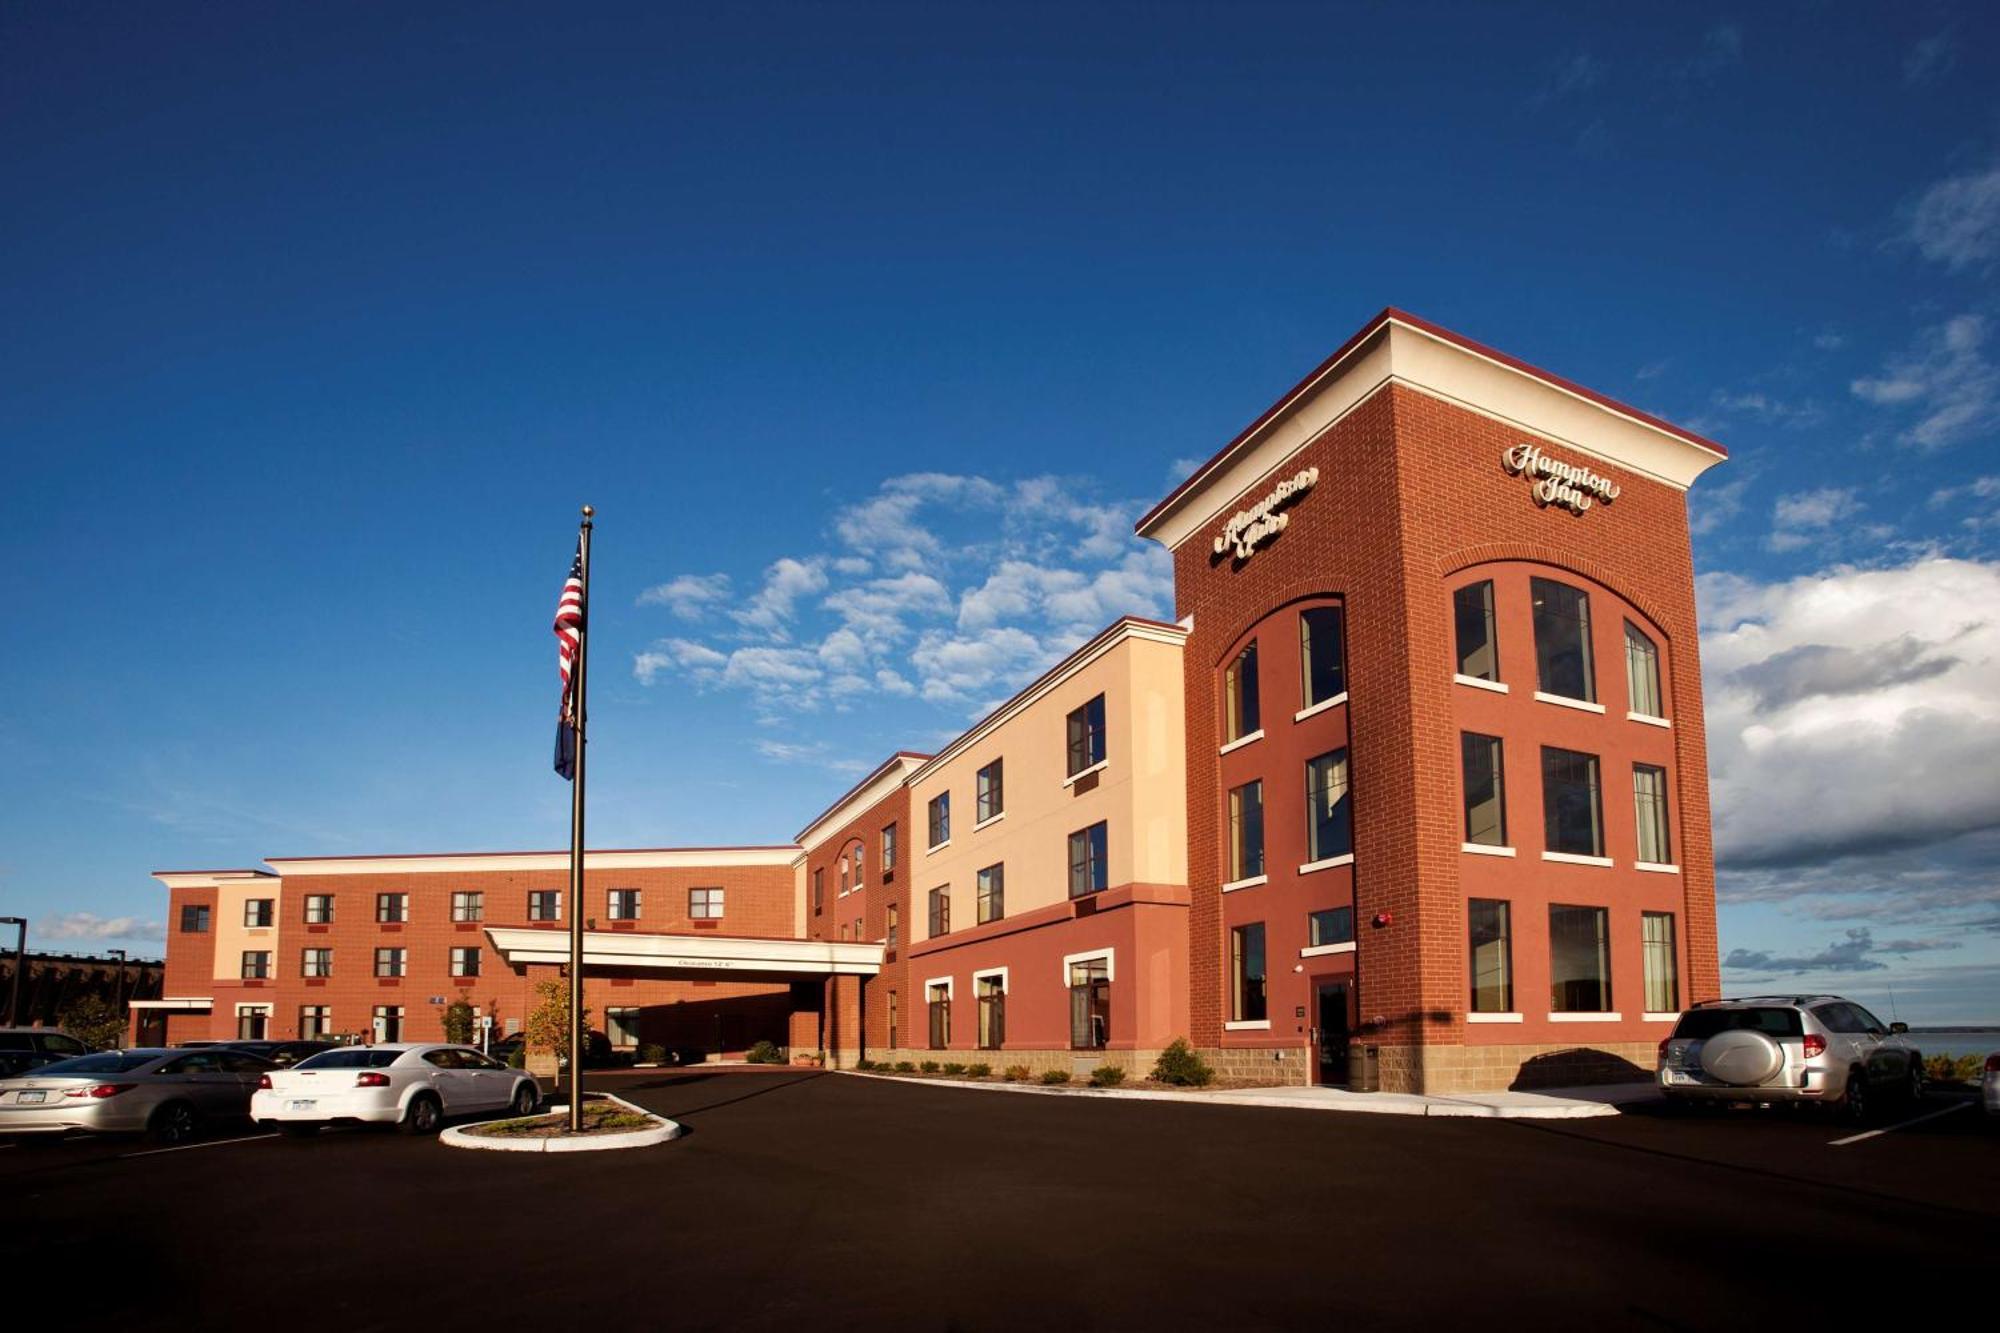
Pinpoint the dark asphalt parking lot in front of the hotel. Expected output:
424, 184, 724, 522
0, 1069, 2000, 1331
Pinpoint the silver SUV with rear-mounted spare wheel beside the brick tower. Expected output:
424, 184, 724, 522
1660, 995, 1924, 1121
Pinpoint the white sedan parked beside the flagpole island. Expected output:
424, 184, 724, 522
250, 1041, 542, 1135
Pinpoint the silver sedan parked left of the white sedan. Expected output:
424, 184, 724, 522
0, 1047, 276, 1145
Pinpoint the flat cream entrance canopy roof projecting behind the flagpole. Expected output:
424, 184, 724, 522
486, 927, 882, 977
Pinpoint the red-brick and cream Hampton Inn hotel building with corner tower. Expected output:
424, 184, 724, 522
154, 310, 1724, 1091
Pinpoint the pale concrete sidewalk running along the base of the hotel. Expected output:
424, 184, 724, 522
840, 1069, 1660, 1121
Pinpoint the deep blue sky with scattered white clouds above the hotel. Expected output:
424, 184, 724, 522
0, 4, 2000, 1019
